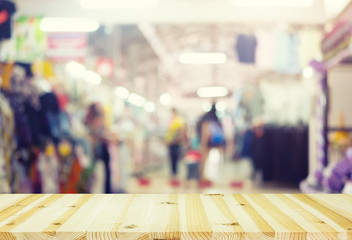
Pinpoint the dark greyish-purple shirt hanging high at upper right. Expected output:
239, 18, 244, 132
236, 35, 257, 63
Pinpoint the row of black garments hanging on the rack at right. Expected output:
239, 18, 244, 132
252, 125, 309, 185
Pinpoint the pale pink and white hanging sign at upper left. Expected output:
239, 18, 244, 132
47, 33, 88, 62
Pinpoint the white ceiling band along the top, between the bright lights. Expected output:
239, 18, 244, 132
16, 0, 327, 24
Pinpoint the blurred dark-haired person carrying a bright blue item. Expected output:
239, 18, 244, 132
197, 103, 225, 186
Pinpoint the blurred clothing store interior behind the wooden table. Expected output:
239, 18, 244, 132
0, 0, 352, 193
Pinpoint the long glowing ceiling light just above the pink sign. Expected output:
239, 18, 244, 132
40, 18, 99, 32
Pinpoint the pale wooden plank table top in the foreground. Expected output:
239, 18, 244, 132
0, 194, 352, 240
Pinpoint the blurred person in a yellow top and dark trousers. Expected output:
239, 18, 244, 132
166, 108, 186, 186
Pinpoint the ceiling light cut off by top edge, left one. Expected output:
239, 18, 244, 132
81, 0, 158, 9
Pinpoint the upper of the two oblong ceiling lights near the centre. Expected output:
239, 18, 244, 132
179, 53, 227, 64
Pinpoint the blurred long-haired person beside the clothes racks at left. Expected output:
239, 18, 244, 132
85, 103, 118, 193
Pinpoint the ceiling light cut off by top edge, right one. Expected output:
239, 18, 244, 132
232, 0, 314, 7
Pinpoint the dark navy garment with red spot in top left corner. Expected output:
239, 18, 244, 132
0, 0, 16, 41
